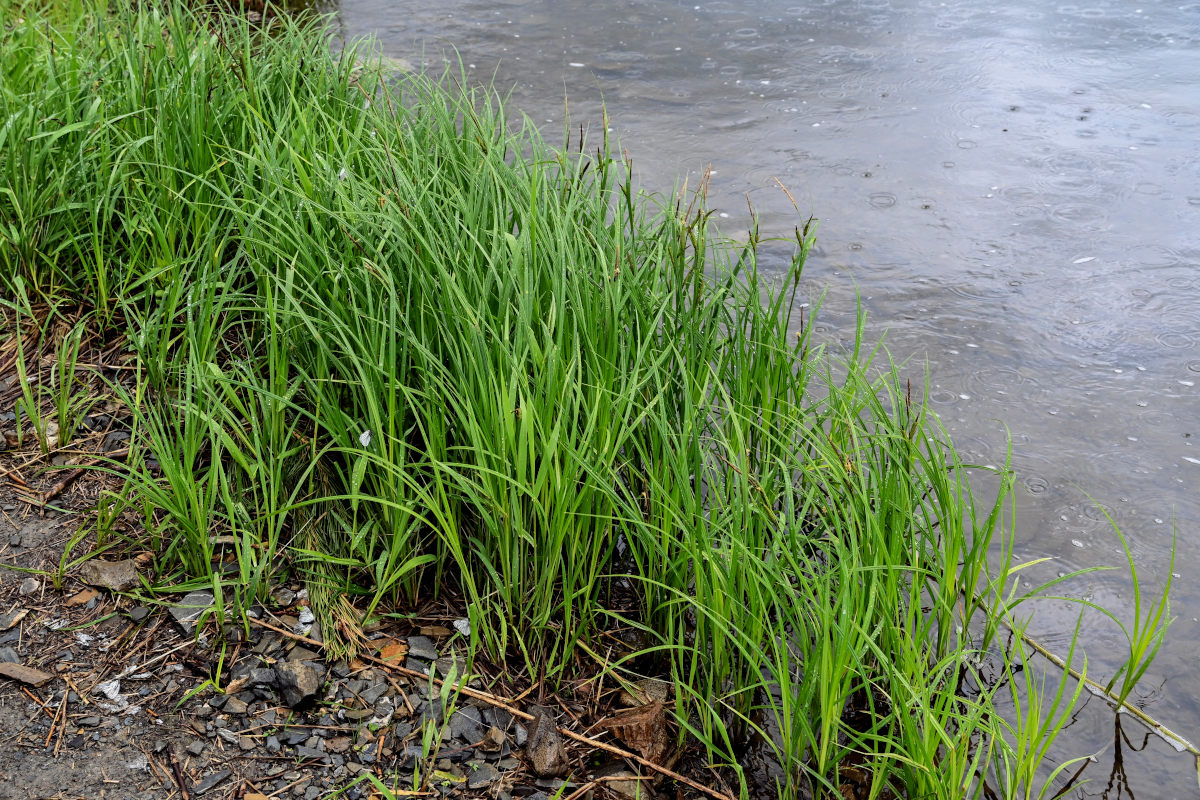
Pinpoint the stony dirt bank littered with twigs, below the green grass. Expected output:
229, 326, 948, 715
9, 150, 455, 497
0, 455, 713, 800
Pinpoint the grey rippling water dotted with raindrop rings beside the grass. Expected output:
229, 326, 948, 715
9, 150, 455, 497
340, 0, 1200, 798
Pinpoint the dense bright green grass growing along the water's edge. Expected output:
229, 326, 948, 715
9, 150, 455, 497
0, 6, 1163, 799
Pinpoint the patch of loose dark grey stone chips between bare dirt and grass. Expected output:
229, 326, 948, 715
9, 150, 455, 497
0, 578, 600, 800
